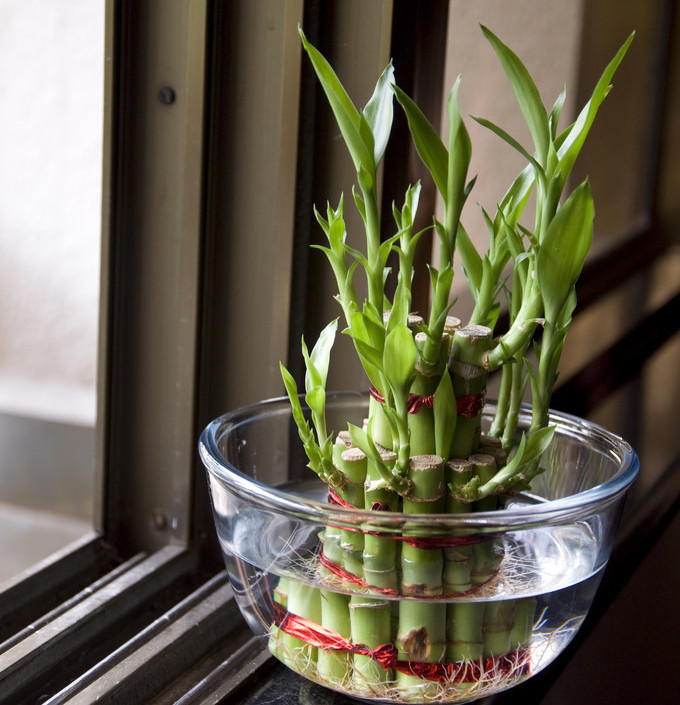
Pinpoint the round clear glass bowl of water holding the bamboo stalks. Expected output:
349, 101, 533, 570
199, 392, 639, 703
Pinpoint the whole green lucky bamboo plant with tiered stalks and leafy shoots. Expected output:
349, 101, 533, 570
271, 27, 633, 699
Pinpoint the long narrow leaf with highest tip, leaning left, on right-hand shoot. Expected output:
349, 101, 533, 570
482, 25, 551, 166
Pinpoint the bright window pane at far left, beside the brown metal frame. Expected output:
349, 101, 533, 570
0, 0, 104, 580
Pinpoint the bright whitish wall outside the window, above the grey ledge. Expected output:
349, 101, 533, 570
0, 0, 104, 424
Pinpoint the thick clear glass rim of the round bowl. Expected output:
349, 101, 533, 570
198, 392, 639, 531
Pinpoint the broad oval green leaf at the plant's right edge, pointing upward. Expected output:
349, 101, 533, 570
536, 181, 595, 324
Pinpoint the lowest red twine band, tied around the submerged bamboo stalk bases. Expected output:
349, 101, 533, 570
273, 602, 530, 683
